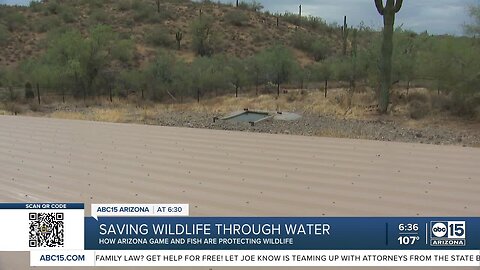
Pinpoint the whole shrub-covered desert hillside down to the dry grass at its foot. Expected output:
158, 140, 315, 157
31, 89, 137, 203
0, 0, 480, 142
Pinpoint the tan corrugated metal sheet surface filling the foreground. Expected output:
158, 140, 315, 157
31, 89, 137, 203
0, 116, 480, 269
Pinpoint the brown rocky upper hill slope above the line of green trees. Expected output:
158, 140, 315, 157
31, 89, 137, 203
0, 0, 341, 67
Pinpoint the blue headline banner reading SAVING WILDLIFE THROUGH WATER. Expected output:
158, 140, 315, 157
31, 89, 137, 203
85, 217, 480, 250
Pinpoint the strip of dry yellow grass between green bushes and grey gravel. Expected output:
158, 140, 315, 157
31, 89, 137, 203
9, 88, 470, 123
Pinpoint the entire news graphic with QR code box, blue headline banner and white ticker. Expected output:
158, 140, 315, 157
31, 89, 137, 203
0, 203, 480, 267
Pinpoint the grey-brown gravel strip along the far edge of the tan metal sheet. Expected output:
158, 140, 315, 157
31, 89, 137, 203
147, 112, 480, 147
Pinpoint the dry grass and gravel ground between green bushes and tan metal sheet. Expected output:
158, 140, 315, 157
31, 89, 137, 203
4, 89, 480, 147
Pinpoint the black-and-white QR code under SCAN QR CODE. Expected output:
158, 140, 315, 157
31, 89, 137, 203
28, 213, 64, 248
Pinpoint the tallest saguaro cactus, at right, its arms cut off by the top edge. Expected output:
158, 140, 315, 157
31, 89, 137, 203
375, 0, 403, 113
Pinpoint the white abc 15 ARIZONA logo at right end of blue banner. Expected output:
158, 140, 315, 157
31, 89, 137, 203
430, 221, 467, 247
